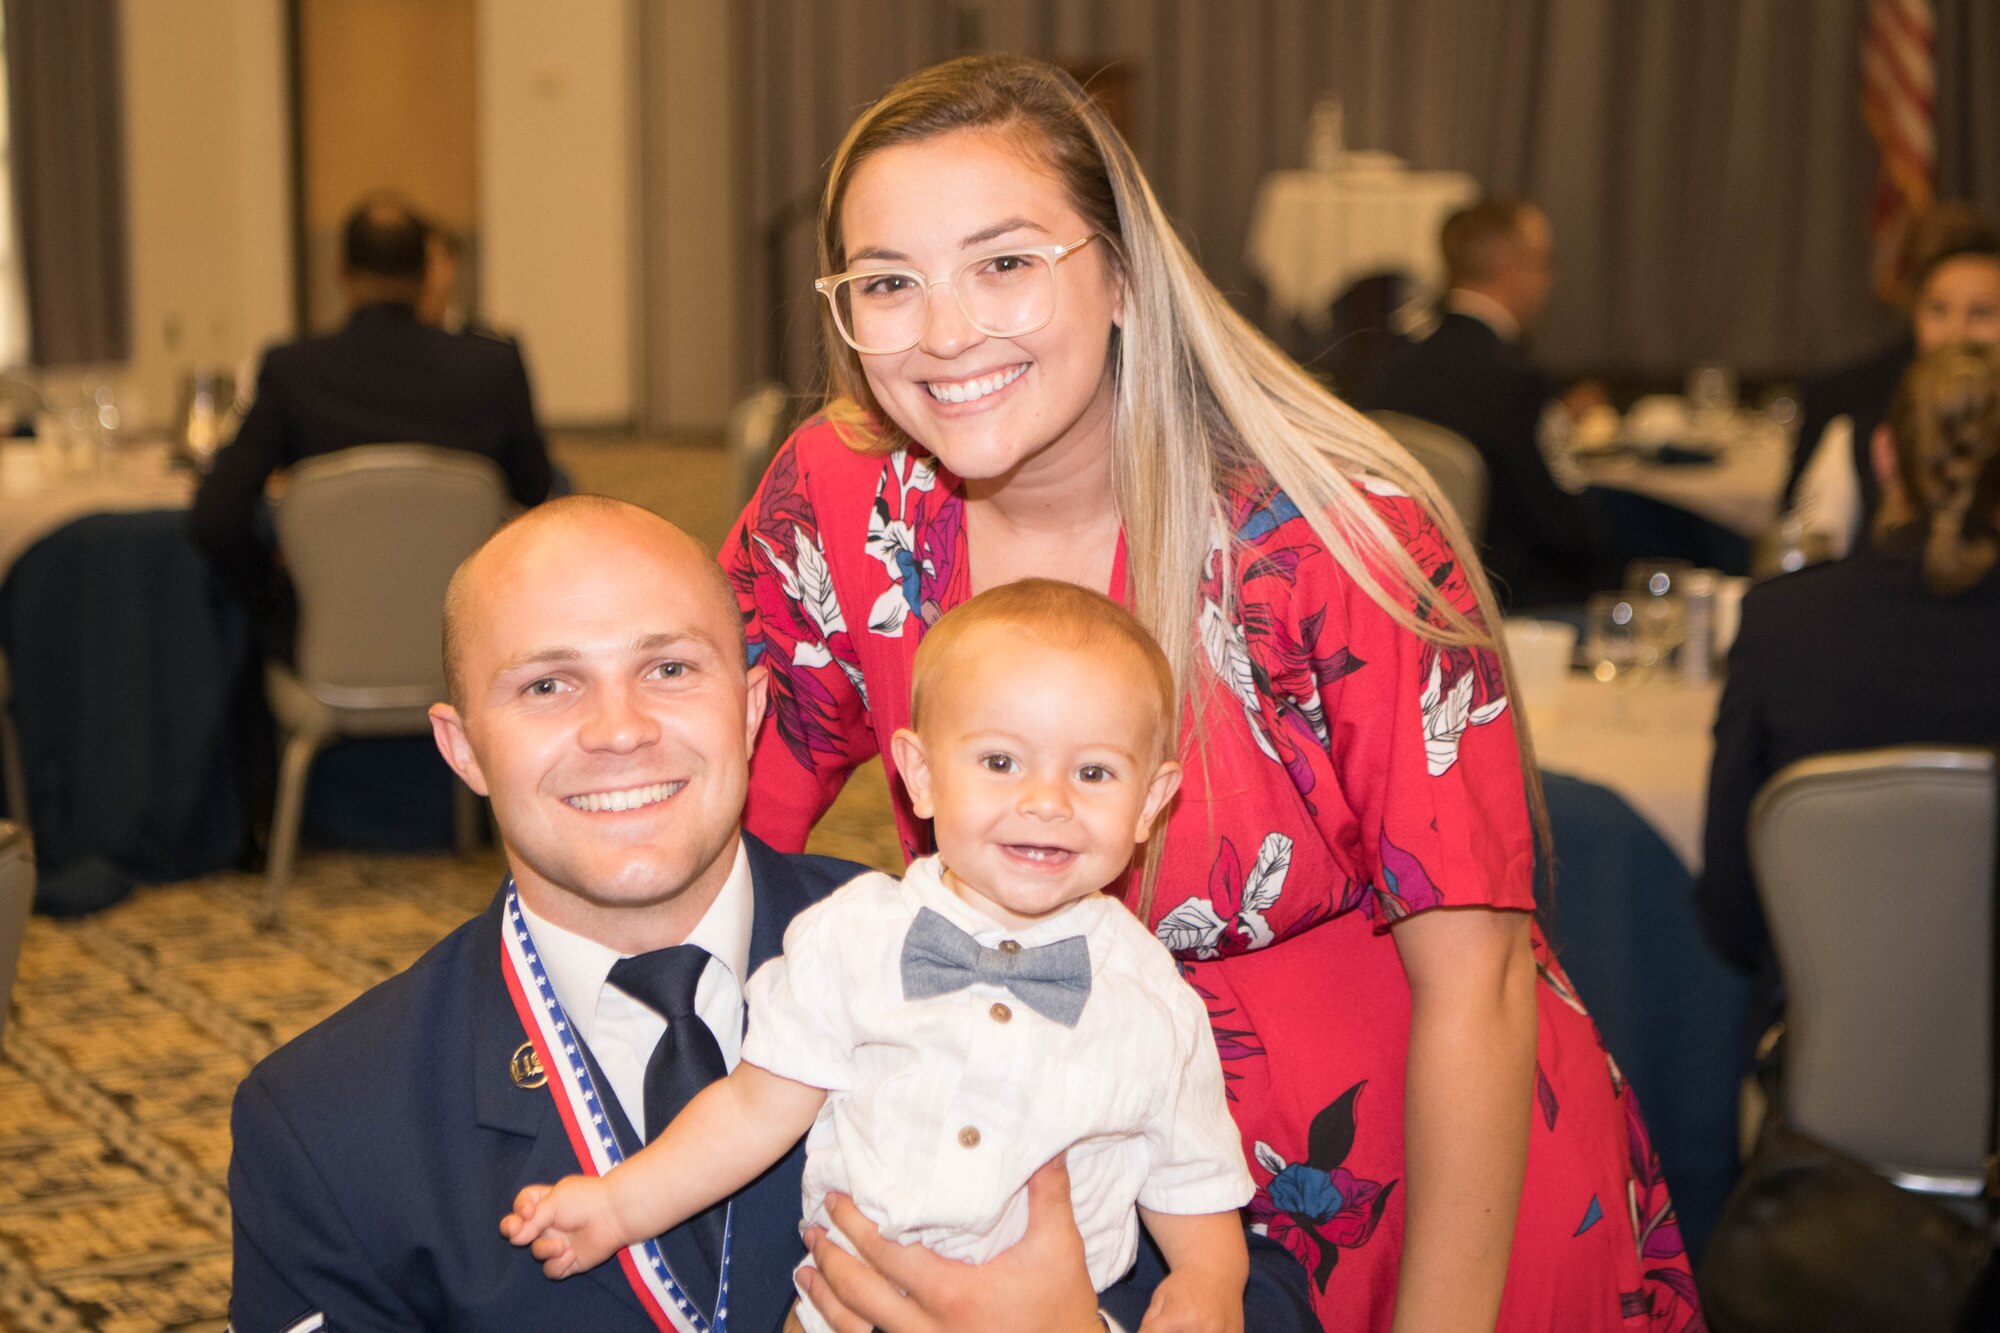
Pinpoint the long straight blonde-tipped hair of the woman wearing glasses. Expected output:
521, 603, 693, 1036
818, 56, 1548, 904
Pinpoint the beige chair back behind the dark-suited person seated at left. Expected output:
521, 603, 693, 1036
276, 444, 508, 709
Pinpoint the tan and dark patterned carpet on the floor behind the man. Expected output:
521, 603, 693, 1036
0, 440, 898, 1333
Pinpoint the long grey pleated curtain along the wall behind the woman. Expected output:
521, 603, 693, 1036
740, 0, 2000, 384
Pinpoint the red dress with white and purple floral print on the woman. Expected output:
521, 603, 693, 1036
722, 420, 1704, 1333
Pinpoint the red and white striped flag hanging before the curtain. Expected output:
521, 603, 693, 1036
1862, 0, 1938, 296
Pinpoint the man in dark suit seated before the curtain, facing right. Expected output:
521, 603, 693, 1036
1362, 198, 1608, 608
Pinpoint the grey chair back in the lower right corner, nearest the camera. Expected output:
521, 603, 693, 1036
1750, 747, 1996, 1197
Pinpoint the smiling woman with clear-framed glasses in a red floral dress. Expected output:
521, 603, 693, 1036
722, 58, 1702, 1331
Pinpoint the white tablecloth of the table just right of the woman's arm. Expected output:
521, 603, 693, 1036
1534, 673, 1722, 871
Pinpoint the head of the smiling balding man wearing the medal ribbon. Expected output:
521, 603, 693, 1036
430, 496, 766, 953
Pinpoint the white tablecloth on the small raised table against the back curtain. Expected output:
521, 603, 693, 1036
1246, 168, 1480, 328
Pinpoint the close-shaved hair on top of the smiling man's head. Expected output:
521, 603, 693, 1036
444, 494, 748, 713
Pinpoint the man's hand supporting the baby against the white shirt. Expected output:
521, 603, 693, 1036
800, 1157, 1104, 1333
